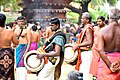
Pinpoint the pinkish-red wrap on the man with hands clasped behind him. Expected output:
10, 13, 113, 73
97, 52, 120, 80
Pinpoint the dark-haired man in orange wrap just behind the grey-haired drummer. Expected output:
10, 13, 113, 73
90, 16, 105, 76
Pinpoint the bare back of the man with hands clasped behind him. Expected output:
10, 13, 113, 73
102, 22, 120, 52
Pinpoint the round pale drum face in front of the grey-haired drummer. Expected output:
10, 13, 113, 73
64, 46, 78, 63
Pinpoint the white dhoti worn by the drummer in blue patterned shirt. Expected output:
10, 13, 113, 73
38, 57, 60, 80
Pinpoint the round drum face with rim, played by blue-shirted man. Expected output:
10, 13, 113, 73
24, 50, 44, 72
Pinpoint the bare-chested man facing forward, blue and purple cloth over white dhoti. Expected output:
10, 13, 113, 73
15, 16, 31, 80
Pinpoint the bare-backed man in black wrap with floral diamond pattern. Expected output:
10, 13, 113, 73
0, 14, 18, 80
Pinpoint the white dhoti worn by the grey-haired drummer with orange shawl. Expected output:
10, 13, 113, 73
79, 50, 92, 80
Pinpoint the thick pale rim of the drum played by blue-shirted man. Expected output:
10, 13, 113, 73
24, 50, 44, 72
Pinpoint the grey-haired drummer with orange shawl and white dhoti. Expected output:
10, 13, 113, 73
73, 12, 93, 80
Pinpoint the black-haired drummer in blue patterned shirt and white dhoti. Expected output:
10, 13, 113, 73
37, 18, 66, 80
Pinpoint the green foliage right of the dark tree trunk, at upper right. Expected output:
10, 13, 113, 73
89, 0, 118, 20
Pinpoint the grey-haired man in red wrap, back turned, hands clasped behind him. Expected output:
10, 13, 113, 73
97, 8, 120, 80
